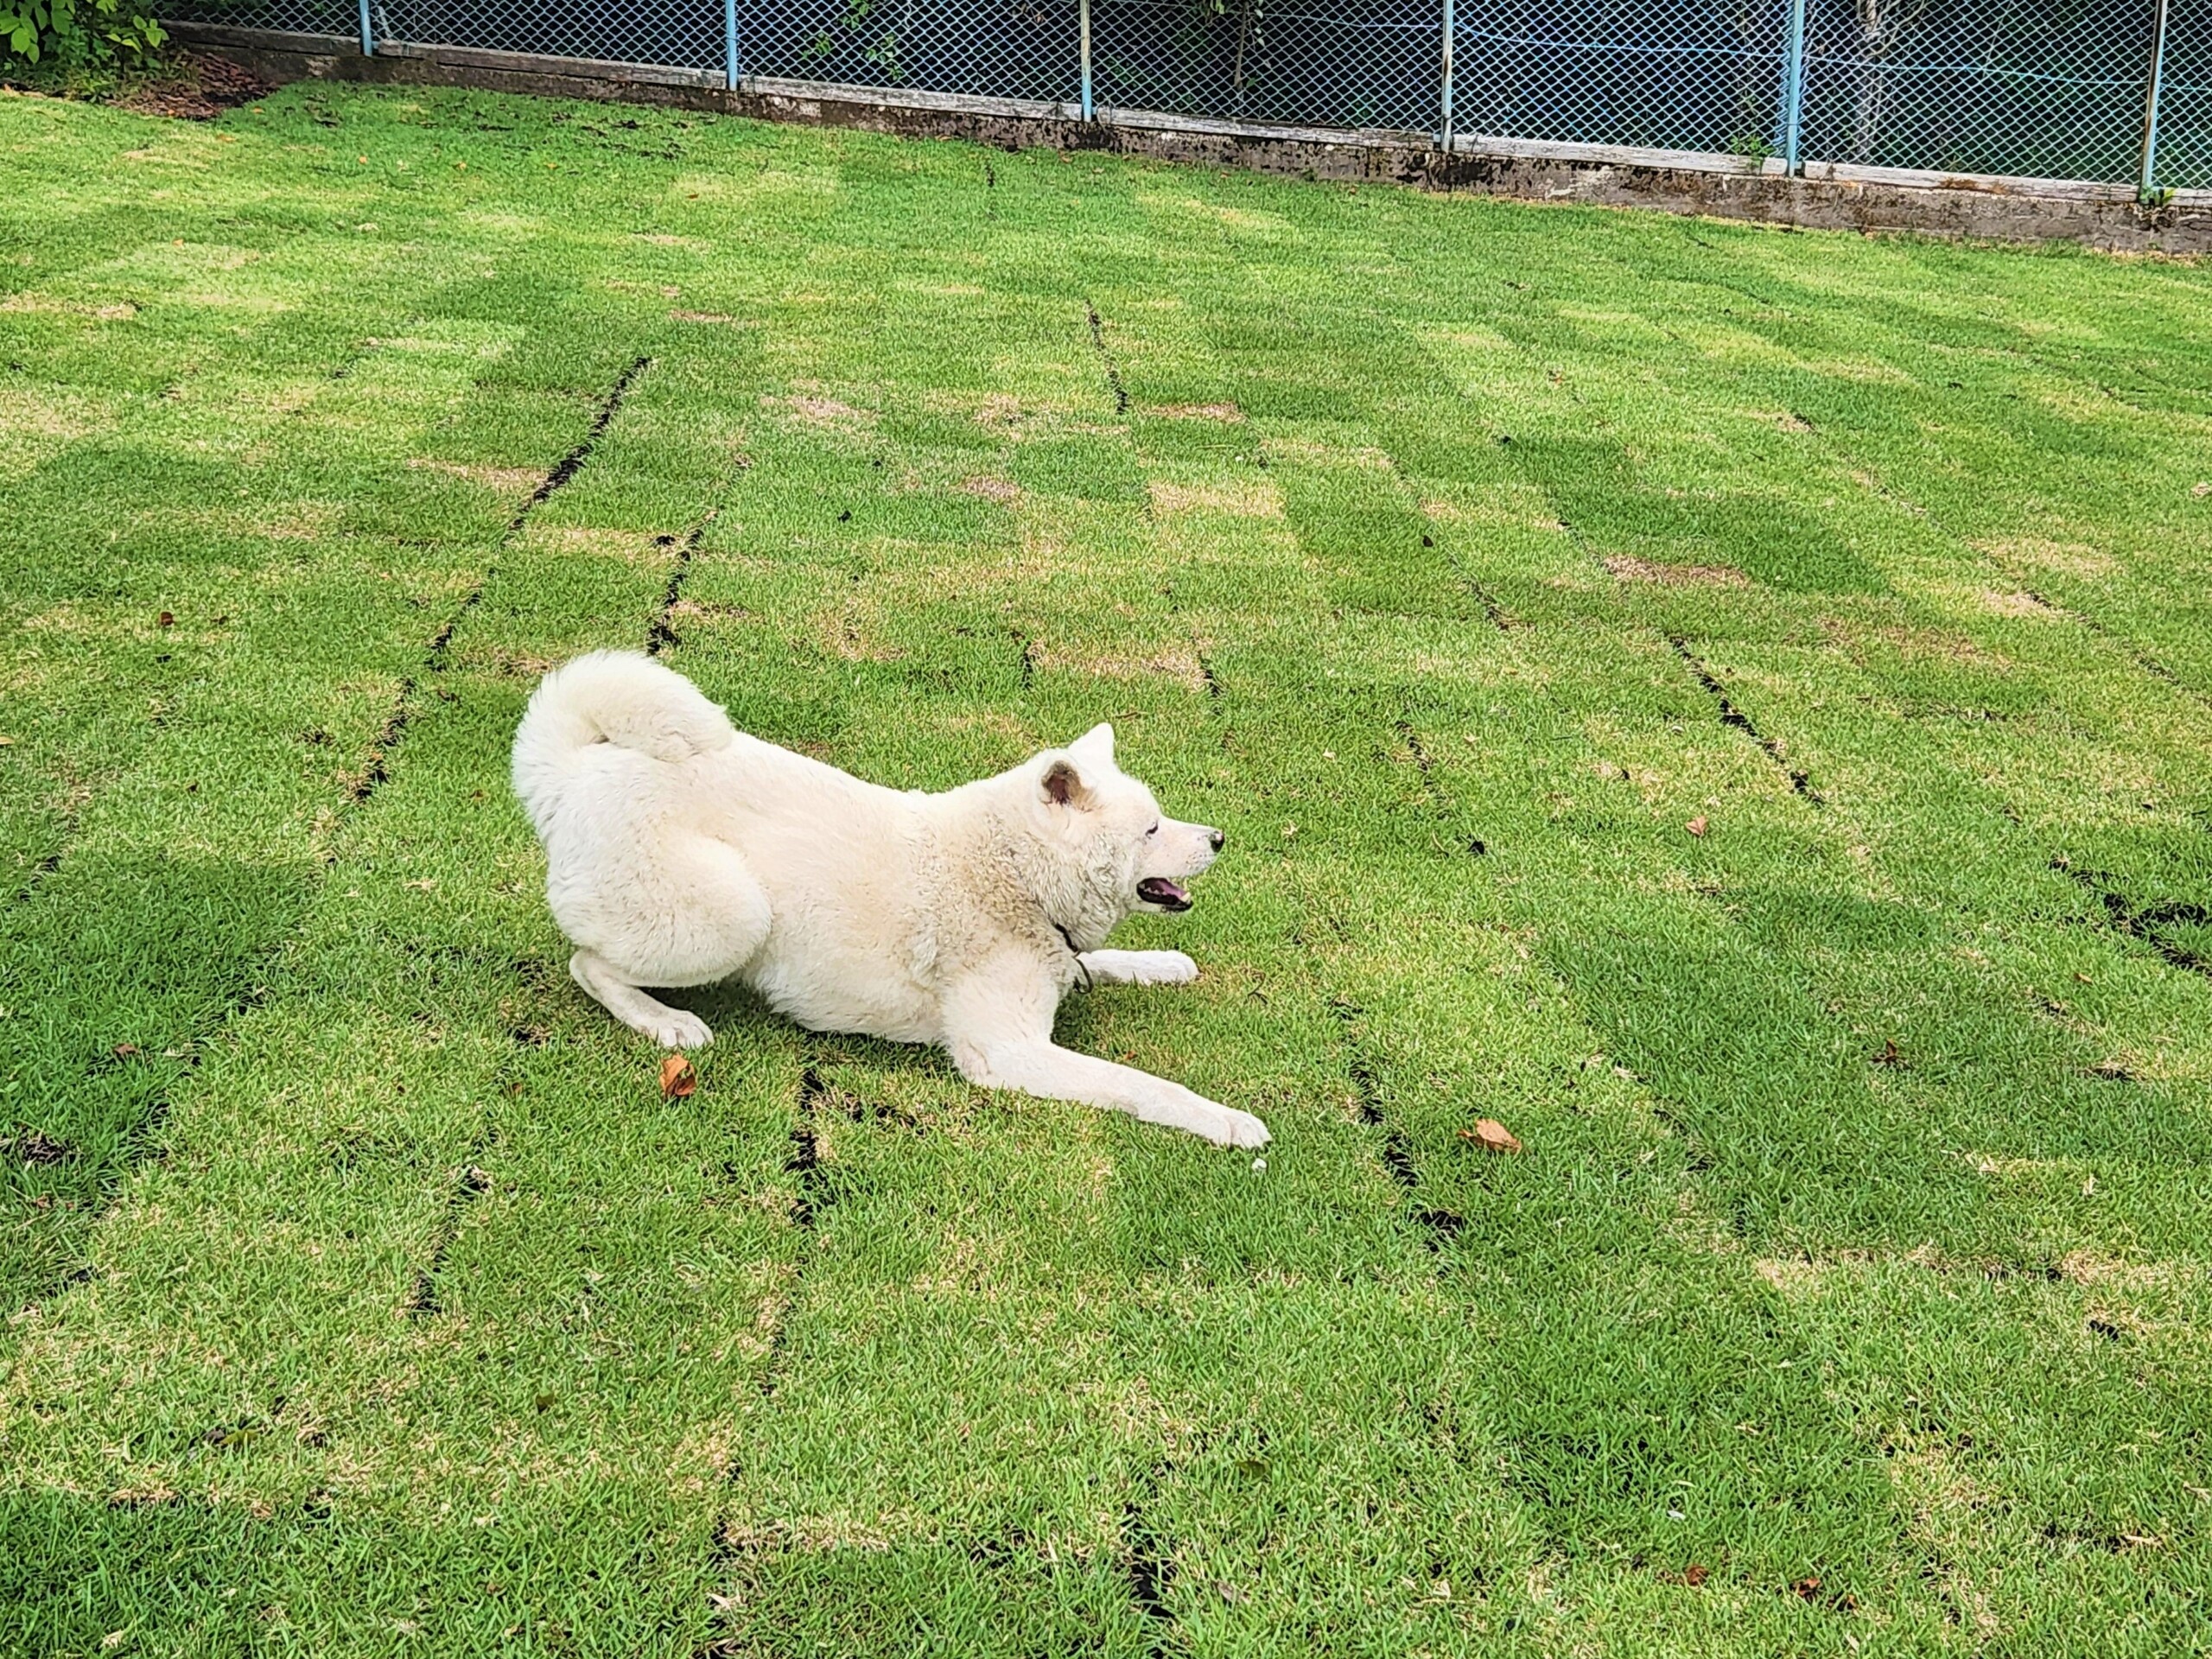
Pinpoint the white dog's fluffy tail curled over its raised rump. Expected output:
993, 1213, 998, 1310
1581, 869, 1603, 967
515, 651, 736, 818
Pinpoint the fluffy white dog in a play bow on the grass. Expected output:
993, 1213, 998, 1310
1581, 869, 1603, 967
502, 651, 1268, 1146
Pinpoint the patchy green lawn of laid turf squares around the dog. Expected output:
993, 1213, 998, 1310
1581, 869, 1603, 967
0, 74, 2212, 1656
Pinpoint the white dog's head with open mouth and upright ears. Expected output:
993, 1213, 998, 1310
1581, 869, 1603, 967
1028, 726, 1224, 927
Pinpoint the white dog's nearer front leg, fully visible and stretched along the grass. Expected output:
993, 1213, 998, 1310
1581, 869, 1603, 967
944, 973, 1268, 1146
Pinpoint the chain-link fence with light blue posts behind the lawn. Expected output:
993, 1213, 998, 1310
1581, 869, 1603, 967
168, 0, 2212, 194
